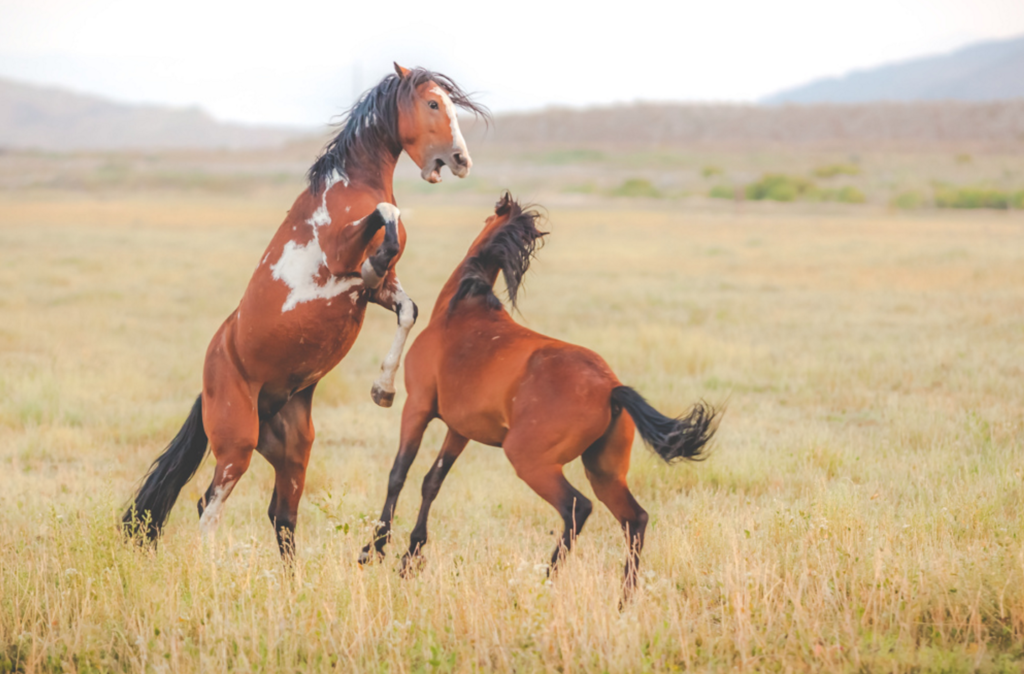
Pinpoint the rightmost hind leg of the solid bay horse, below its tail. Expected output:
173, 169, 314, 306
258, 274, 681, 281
583, 414, 647, 603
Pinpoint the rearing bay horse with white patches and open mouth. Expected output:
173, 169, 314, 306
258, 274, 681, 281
123, 64, 488, 559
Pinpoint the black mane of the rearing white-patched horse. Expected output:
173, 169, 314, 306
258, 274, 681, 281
306, 68, 490, 197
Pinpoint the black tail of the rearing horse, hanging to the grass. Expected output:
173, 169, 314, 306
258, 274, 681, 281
123, 395, 207, 541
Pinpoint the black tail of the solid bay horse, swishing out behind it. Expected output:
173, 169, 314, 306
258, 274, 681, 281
611, 386, 721, 463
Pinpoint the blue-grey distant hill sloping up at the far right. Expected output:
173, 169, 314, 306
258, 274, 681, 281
764, 36, 1024, 103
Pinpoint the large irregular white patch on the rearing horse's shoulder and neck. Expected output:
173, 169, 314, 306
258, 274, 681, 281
270, 171, 362, 313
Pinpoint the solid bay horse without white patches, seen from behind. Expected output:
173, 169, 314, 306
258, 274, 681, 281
359, 193, 720, 599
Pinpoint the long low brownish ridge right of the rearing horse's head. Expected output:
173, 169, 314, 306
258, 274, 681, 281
463, 100, 1024, 150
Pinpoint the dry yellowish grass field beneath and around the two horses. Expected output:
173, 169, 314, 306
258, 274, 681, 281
0, 188, 1024, 673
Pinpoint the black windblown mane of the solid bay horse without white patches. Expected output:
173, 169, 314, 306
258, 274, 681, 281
449, 192, 548, 314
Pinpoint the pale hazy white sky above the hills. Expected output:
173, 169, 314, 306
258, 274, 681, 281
0, 0, 1024, 125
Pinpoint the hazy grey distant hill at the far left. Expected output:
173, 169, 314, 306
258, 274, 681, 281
0, 79, 309, 151
